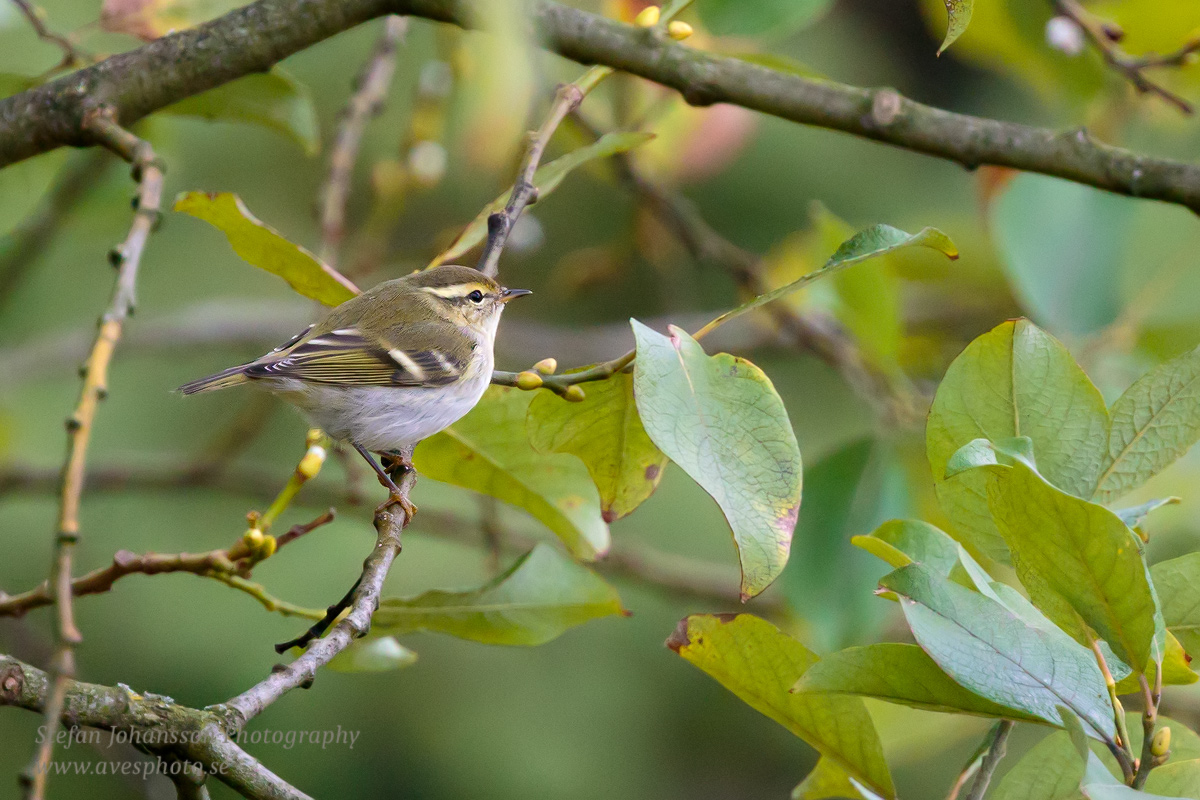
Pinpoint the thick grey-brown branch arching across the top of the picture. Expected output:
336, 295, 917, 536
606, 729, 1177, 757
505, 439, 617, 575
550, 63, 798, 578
0, 0, 1200, 211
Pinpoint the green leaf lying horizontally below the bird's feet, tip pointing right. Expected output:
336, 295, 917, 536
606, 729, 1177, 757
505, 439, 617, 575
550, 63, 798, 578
371, 545, 625, 645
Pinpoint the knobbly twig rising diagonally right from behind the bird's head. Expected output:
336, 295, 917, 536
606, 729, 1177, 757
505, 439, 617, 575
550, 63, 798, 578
475, 67, 613, 277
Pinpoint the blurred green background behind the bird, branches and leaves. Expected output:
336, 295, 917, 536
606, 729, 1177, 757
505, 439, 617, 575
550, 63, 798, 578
0, 0, 1200, 800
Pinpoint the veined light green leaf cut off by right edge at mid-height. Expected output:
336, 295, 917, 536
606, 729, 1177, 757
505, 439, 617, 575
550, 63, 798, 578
1096, 348, 1200, 503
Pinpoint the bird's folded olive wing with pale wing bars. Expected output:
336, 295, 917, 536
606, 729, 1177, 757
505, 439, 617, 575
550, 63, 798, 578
245, 323, 470, 386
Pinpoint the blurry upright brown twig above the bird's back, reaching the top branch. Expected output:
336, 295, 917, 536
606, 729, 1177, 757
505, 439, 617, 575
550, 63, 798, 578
318, 16, 408, 266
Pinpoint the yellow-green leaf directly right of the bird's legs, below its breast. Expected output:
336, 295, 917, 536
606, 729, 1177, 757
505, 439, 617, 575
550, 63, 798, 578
413, 386, 608, 560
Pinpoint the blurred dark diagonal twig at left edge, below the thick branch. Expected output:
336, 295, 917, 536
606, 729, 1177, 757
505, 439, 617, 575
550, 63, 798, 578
0, 149, 112, 307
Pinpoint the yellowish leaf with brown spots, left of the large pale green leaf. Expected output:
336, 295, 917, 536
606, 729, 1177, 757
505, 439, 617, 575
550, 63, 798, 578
526, 372, 667, 522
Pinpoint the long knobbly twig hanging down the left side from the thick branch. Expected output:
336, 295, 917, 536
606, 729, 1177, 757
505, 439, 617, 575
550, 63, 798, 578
20, 109, 163, 800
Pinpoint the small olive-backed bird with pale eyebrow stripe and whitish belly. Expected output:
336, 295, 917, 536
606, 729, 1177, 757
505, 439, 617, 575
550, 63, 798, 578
179, 265, 530, 515
